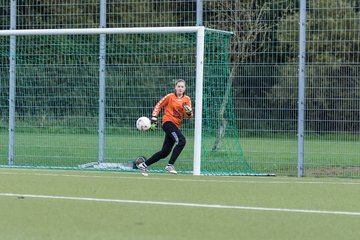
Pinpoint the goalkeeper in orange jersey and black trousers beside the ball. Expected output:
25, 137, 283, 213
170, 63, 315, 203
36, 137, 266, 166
136, 79, 193, 174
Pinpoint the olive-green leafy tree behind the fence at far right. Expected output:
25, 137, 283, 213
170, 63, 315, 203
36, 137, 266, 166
269, 0, 360, 131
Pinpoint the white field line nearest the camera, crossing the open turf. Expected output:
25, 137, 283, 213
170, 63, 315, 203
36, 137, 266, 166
0, 193, 360, 216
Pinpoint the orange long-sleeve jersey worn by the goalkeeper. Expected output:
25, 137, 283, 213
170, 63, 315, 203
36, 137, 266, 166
152, 93, 193, 128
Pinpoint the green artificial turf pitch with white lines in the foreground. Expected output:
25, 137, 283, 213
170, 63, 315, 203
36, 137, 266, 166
0, 168, 360, 240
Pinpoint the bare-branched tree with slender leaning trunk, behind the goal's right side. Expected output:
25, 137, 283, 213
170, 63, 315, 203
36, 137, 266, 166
204, 0, 289, 146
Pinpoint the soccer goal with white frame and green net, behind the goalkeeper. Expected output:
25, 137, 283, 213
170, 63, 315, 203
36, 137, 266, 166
0, 27, 256, 175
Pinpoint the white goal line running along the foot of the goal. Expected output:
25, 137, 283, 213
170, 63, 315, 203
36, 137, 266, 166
0, 170, 360, 185
